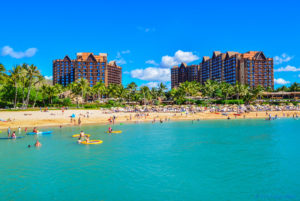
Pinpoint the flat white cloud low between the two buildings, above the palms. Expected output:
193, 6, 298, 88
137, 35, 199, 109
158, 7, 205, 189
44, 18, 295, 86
130, 67, 171, 82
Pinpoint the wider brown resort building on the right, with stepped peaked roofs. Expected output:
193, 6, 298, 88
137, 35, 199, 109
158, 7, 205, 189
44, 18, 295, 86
171, 51, 274, 89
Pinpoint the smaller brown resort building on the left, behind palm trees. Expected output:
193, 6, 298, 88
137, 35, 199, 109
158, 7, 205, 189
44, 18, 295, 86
53, 52, 122, 86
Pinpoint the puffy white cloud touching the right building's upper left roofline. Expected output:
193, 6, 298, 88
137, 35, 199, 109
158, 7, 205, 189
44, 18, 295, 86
161, 50, 199, 68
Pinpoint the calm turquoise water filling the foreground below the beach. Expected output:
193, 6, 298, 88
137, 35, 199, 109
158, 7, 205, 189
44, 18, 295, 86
0, 119, 300, 201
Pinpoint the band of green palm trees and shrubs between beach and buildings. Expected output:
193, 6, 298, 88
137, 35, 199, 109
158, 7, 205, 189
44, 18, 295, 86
0, 64, 300, 109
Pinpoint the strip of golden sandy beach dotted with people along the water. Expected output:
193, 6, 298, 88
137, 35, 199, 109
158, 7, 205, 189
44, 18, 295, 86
0, 110, 300, 130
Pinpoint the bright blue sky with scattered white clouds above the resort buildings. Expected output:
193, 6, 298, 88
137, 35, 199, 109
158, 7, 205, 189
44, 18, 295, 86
0, 0, 300, 87
